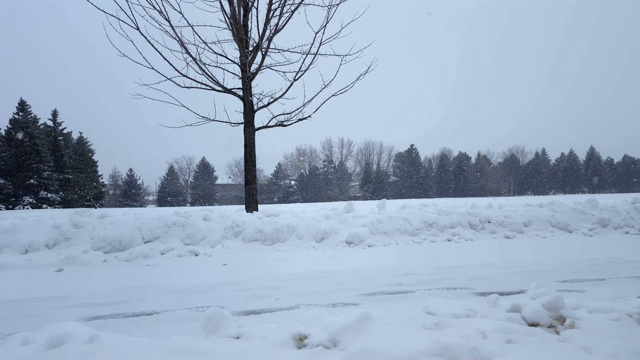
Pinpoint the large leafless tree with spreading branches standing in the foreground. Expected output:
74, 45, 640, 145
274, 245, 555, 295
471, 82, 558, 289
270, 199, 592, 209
87, 0, 375, 212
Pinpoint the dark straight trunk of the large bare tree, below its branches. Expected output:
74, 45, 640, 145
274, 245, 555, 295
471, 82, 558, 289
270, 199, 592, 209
244, 115, 258, 213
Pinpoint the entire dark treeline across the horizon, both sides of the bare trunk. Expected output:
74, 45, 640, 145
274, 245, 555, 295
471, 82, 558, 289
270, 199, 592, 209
0, 99, 640, 210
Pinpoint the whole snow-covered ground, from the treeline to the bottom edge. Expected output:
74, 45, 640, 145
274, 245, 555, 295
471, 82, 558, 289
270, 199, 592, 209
0, 194, 640, 359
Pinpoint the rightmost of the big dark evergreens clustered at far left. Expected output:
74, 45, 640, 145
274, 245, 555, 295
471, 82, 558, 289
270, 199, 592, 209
63, 133, 105, 208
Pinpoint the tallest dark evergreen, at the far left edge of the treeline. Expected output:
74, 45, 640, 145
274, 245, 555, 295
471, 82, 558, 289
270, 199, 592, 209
2, 98, 58, 209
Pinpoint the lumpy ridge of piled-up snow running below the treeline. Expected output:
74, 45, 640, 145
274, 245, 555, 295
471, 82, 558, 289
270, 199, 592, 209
0, 194, 640, 265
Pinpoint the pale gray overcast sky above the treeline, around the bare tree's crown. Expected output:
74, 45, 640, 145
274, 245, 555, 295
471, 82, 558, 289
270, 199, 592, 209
0, 0, 640, 185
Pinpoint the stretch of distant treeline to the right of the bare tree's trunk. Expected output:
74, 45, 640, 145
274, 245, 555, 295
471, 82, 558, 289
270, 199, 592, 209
259, 138, 640, 203
